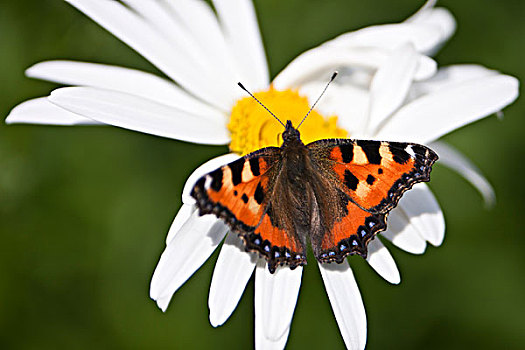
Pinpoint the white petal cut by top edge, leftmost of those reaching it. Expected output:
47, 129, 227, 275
66, 0, 233, 110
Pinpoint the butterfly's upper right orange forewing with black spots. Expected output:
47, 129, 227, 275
307, 139, 438, 213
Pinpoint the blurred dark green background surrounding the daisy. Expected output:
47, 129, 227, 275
0, 0, 525, 349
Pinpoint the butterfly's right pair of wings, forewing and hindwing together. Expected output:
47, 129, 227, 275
307, 139, 438, 262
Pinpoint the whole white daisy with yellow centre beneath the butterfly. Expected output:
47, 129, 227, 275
6, 0, 518, 349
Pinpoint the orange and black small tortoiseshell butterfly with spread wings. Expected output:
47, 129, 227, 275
191, 74, 438, 273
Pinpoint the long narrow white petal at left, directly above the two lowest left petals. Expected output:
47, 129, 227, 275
26, 61, 224, 120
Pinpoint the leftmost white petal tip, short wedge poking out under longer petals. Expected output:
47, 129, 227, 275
5, 97, 100, 125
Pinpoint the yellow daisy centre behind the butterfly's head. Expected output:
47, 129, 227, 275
228, 87, 348, 155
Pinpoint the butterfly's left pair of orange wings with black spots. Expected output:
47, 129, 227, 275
191, 147, 306, 272
